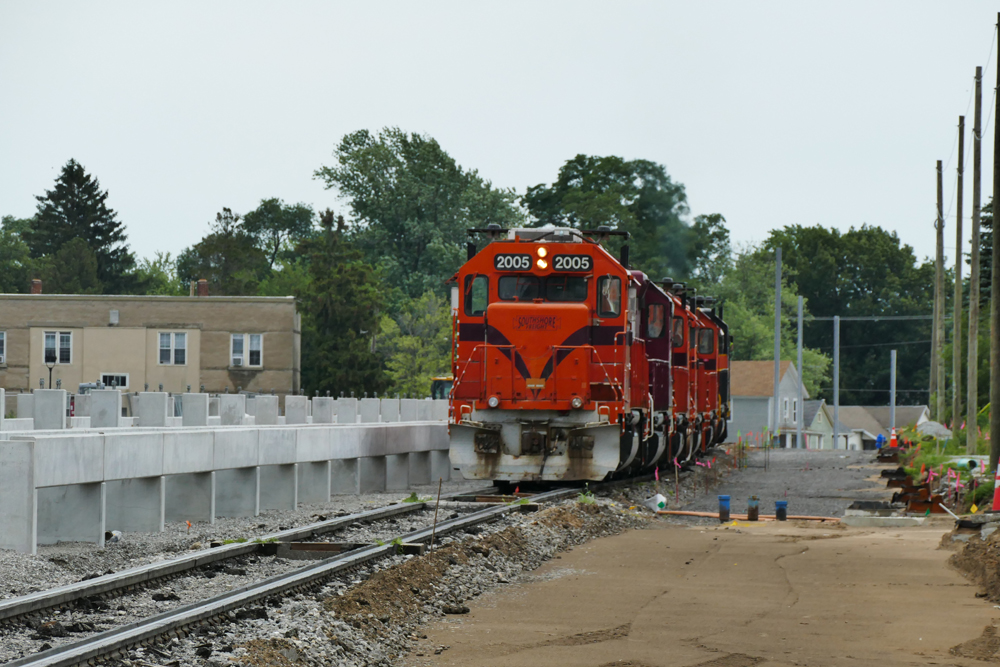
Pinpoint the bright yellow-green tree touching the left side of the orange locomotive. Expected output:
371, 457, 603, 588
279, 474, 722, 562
379, 290, 451, 396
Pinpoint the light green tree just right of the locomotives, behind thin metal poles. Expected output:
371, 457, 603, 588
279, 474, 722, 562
713, 246, 832, 397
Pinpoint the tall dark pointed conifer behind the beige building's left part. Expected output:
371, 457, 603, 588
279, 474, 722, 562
25, 159, 139, 294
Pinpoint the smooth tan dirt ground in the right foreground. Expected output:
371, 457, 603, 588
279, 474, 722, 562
407, 522, 1000, 667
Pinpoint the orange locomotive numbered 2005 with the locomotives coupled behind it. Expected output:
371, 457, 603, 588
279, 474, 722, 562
450, 225, 729, 484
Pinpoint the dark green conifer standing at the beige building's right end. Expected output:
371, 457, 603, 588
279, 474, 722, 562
297, 215, 387, 395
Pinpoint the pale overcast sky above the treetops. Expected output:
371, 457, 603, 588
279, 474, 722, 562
0, 0, 997, 264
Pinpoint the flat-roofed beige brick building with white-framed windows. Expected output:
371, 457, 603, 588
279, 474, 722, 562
0, 294, 301, 396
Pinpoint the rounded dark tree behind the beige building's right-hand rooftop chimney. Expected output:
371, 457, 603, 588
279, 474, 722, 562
177, 208, 268, 296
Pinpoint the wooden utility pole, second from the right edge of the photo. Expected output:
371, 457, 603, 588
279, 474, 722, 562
965, 67, 983, 454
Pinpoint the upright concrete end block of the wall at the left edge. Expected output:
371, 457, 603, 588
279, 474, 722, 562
0, 440, 38, 554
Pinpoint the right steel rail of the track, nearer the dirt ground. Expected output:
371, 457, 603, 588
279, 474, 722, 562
6, 488, 579, 667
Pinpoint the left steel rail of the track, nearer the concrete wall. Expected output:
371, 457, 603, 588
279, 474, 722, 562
0, 487, 492, 623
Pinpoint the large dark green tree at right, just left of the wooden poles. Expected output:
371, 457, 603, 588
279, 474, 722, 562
763, 225, 936, 405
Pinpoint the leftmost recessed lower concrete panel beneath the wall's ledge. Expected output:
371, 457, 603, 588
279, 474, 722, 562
37, 483, 105, 546
